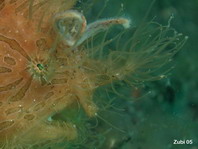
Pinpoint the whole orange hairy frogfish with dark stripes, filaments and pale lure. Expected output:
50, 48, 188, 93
0, 0, 185, 148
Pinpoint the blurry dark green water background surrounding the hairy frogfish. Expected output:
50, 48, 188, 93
63, 0, 198, 149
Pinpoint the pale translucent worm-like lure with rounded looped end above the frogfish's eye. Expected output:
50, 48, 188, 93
54, 10, 130, 47
